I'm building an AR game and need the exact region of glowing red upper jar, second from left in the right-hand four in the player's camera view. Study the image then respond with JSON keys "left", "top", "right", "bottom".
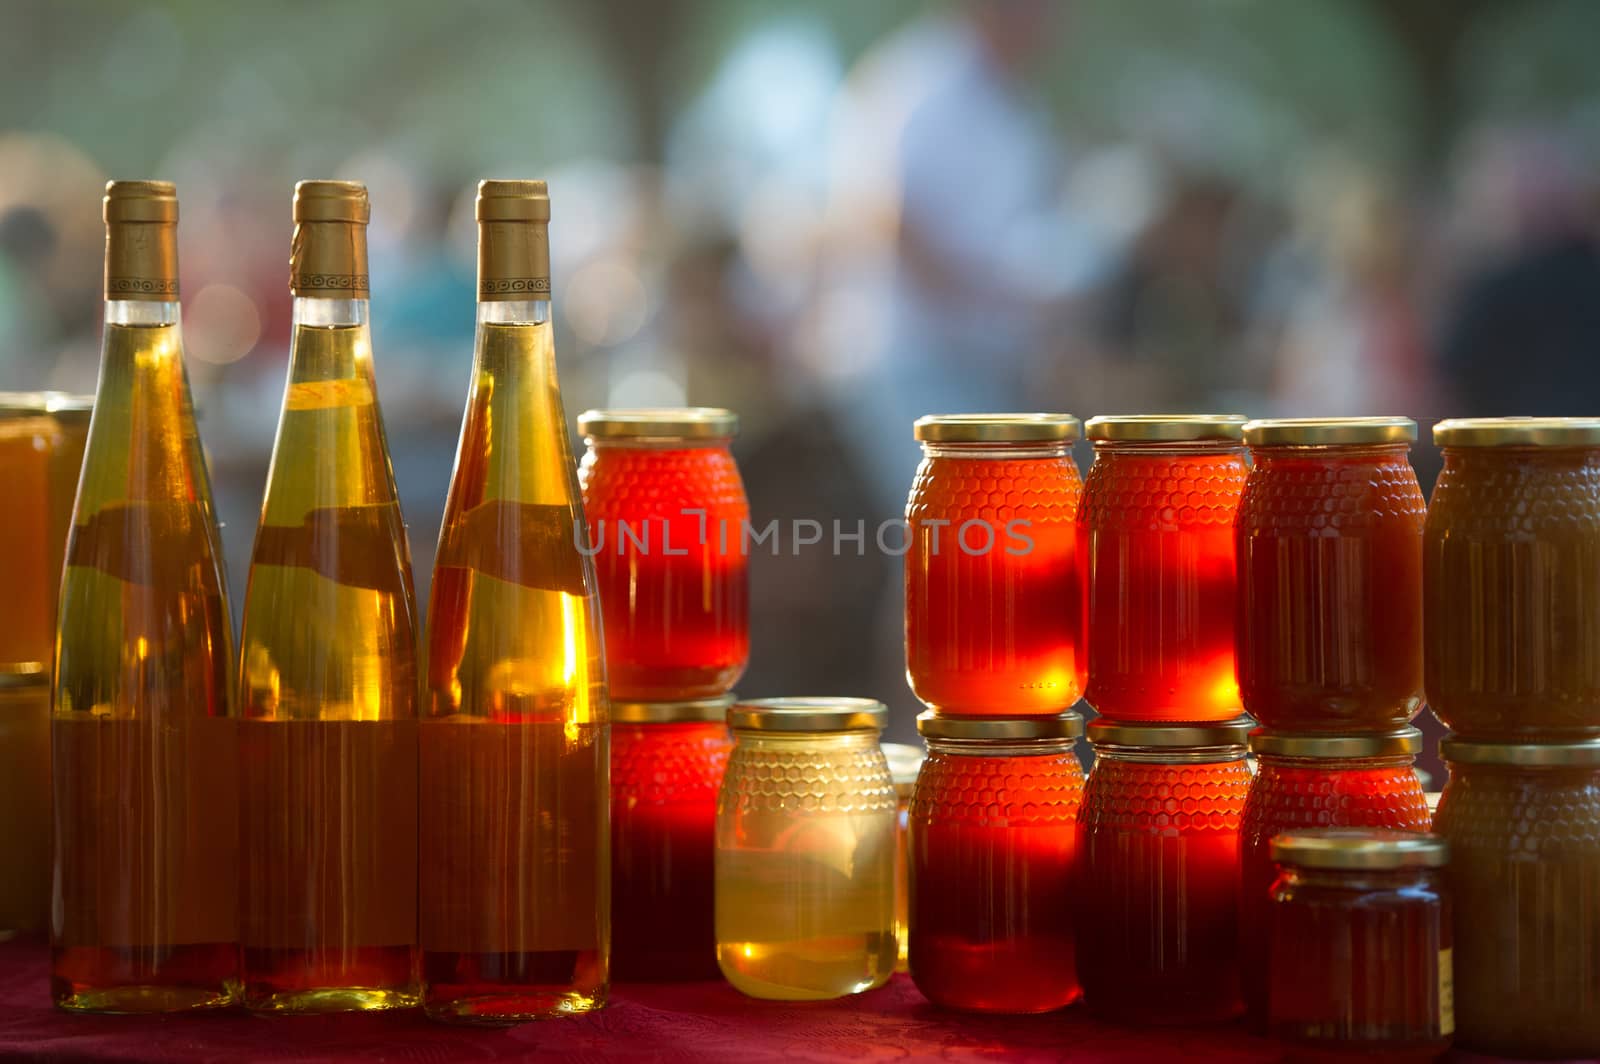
{"left": 1078, "top": 414, "right": 1246, "bottom": 722}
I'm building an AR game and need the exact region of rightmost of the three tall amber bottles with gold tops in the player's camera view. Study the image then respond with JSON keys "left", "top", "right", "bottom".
{"left": 419, "top": 181, "right": 611, "bottom": 1022}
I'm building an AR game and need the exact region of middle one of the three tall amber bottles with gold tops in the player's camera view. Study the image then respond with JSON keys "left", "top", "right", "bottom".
{"left": 240, "top": 181, "right": 419, "bottom": 1013}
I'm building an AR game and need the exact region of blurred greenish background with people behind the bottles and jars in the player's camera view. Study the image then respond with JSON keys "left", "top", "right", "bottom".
{"left": 0, "top": 0, "right": 1600, "bottom": 736}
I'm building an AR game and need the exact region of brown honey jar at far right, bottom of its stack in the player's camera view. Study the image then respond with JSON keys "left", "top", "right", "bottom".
{"left": 1434, "top": 739, "right": 1600, "bottom": 1058}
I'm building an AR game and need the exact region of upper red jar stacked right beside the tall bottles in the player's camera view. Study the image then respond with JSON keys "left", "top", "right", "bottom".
{"left": 578, "top": 406, "right": 750, "bottom": 702}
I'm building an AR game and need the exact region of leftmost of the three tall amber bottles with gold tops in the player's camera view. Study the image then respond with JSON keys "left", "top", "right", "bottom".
{"left": 50, "top": 181, "right": 238, "bottom": 1013}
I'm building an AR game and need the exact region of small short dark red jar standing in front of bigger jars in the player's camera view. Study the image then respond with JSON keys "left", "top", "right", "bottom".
{"left": 1266, "top": 827, "right": 1456, "bottom": 1064}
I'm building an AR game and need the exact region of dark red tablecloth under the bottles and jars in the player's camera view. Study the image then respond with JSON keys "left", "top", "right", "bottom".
{"left": 0, "top": 942, "right": 1523, "bottom": 1064}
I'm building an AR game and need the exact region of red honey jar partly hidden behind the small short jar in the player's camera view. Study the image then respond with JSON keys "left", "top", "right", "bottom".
{"left": 1238, "top": 728, "right": 1429, "bottom": 1026}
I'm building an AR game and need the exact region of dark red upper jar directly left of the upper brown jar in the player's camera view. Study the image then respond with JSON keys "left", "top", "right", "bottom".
{"left": 1235, "top": 418, "right": 1427, "bottom": 733}
